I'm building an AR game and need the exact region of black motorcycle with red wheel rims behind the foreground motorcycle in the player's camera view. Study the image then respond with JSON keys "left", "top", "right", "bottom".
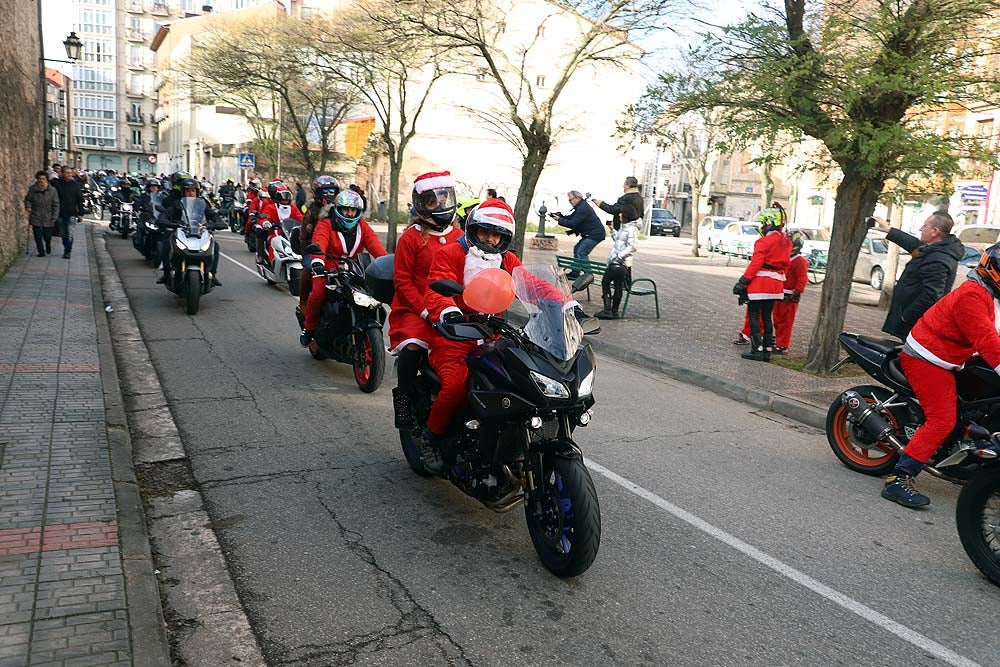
{"left": 295, "top": 244, "right": 387, "bottom": 394}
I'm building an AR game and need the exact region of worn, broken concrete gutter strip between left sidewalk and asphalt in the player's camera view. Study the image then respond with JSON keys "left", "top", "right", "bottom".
{"left": 90, "top": 224, "right": 266, "bottom": 667}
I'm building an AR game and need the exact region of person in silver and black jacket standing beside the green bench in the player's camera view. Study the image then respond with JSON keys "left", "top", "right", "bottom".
{"left": 587, "top": 176, "right": 642, "bottom": 320}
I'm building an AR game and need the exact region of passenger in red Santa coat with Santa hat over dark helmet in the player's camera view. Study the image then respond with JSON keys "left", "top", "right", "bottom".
{"left": 389, "top": 171, "right": 462, "bottom": 428}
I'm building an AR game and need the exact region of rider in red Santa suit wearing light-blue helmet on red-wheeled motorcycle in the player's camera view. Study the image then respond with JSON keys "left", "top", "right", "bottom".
{"left": 299, "top": 190, "right": 386, "bottom": 347}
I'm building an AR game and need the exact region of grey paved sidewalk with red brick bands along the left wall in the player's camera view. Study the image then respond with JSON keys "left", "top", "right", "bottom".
{"left": 0, "top": 223, "right": 170, "bottom": 667}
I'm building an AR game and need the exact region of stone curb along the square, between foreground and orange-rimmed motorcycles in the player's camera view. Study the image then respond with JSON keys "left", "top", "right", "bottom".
{"left": 589, "top": 336, "right": 826, "bottom": 430}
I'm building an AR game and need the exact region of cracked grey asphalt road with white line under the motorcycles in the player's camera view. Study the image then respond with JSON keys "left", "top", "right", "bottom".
{"left": 108, "top": 232, "right": 1000, "bottom": 667}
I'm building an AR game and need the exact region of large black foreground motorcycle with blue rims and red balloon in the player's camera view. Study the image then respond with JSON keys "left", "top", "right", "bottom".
{"left": 370, "top": 258, "right": 601, "bottom": 577}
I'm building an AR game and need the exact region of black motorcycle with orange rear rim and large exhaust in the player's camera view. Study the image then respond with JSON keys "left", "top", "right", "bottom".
{"left": 826, "top": 332, "right": 1000, "bottom": 484}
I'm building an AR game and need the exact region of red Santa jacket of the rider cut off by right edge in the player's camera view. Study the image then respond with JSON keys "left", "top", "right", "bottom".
{"left": 903, "top": 280, "right": 1000, "bottom": 373}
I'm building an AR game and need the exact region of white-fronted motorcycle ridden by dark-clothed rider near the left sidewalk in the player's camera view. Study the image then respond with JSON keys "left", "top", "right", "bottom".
{"left": 162, "top": 197, "right": 224, "bottom": 315}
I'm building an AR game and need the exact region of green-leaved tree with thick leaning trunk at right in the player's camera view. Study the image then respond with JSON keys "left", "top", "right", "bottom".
{"left": 658, "top": 0, "right": 1000, "bottom": 372}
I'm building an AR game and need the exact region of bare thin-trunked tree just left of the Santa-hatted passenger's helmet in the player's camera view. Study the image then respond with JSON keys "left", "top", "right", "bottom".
{"left": 310, "top": 0, "right": 443, "bottom": 251}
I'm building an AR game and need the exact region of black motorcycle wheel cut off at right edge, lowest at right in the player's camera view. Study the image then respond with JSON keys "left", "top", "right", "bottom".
{"left": 955, "top": 466, "right": 1000, "bottom": 586}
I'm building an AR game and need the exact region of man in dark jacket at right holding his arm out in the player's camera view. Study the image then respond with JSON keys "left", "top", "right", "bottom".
{"left": 875, "top": 211, "right": 965, "bottom": 340}
